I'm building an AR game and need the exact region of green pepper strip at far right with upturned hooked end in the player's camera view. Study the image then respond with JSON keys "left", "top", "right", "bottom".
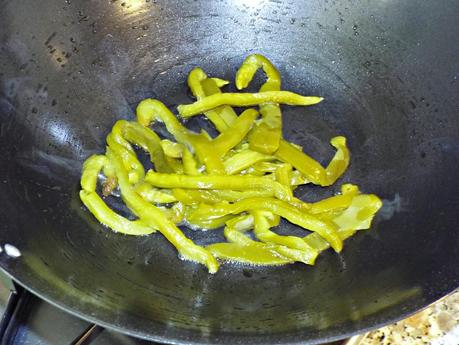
{"left": 275, "top": 137, "right": 349, "bottom": 186}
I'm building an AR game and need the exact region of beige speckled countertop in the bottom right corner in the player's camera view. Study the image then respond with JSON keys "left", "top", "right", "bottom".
{"left": 346, "top": 289, "right": 459, "bottom": 345}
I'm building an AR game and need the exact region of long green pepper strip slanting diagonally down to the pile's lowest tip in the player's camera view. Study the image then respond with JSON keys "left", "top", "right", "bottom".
{"left": 107, "top": 147, "right": 218, "bottom": 273}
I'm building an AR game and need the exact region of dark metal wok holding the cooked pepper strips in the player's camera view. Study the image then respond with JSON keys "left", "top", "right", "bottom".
{"left": 0, "top": 0, "right": 459, "bottom": 344}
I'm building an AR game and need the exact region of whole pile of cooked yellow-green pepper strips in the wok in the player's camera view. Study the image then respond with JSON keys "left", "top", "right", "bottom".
{"left": 80, "top": 54, "right": 382, "bottom": 273}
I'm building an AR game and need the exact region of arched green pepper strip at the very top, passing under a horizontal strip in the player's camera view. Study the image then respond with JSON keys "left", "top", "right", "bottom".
{"left": 236, "top": 54, "right": 282, "bottom": 154}
